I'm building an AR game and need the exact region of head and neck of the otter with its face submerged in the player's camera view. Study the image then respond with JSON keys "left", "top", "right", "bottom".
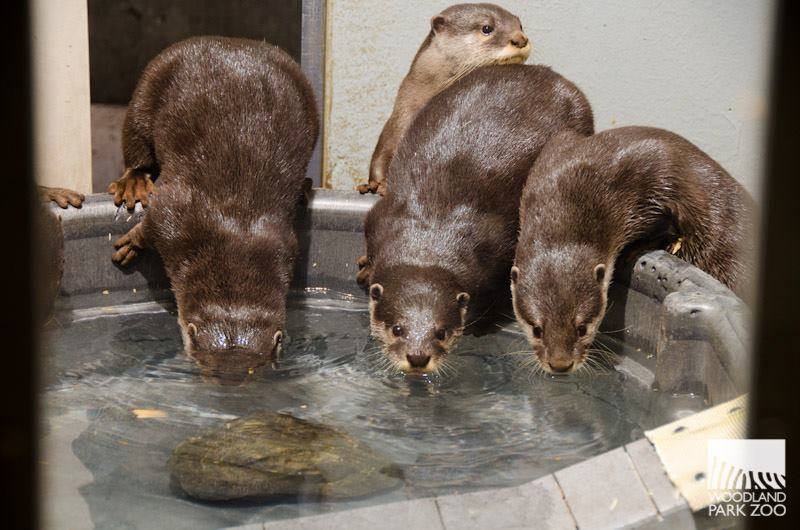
{"left": 165, "top": 229, "right": 293, "bottom": 382}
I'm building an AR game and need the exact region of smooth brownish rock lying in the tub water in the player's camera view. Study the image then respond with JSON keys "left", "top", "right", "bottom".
{"left": 169, "top": 412, "right": 402, "bottom": 501}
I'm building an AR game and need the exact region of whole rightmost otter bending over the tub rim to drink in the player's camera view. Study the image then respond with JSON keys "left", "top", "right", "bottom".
{"left": 511, "top": 127, "right": 754, "bottom": 372}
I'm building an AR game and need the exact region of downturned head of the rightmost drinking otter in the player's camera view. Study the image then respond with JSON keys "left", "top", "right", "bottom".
{"left": 511, "top": 246, "right": 611, "bottom": 373}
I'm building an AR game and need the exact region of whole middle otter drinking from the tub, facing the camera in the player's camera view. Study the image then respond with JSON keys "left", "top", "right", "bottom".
{"left": 358, "top": 65, "right": 593, "bottom": 372}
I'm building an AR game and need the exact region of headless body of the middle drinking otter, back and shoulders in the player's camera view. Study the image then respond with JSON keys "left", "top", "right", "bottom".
{"left": 366, "top": 65, "right": 593, "bottom": 330}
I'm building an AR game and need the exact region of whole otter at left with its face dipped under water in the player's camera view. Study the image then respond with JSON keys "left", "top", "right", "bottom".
{"left": 108, "top": 37, "right": 318, "bottom": 378}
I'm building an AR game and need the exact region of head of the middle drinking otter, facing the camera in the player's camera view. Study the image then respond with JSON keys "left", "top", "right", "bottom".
{"left": 369, "top": 268, "right": 469, "bottom": 373}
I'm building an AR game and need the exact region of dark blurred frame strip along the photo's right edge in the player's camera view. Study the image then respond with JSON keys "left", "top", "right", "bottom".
{"left": 746, "top": 0, "right": 800, "bottom": 528}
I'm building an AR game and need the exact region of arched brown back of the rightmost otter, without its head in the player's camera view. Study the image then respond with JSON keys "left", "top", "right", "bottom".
{"left": 517, "top": 127, "right": 755, "bottom": 294}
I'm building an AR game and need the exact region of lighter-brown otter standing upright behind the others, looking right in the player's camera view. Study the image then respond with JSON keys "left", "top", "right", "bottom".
{"left": 358, "top": 4, "right": 531, "bottom": 195}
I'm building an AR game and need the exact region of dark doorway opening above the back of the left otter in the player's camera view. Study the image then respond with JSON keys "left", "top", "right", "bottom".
{"left": 89, "top": 0, "right": 302, "bottom": 105}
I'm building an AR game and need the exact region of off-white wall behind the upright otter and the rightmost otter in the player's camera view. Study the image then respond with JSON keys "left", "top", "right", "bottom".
{"left": 325, "top": 0, "right": 773, "bottom": 193}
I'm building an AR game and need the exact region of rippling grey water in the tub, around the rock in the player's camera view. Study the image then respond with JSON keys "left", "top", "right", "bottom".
{"left": 42, "top": 297, "right": 701, "bottom": 530}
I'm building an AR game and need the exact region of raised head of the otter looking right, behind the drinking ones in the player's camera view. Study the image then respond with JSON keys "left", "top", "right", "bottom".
{"left": 431, "top": 4, "right": 531, "bottom": 69}
